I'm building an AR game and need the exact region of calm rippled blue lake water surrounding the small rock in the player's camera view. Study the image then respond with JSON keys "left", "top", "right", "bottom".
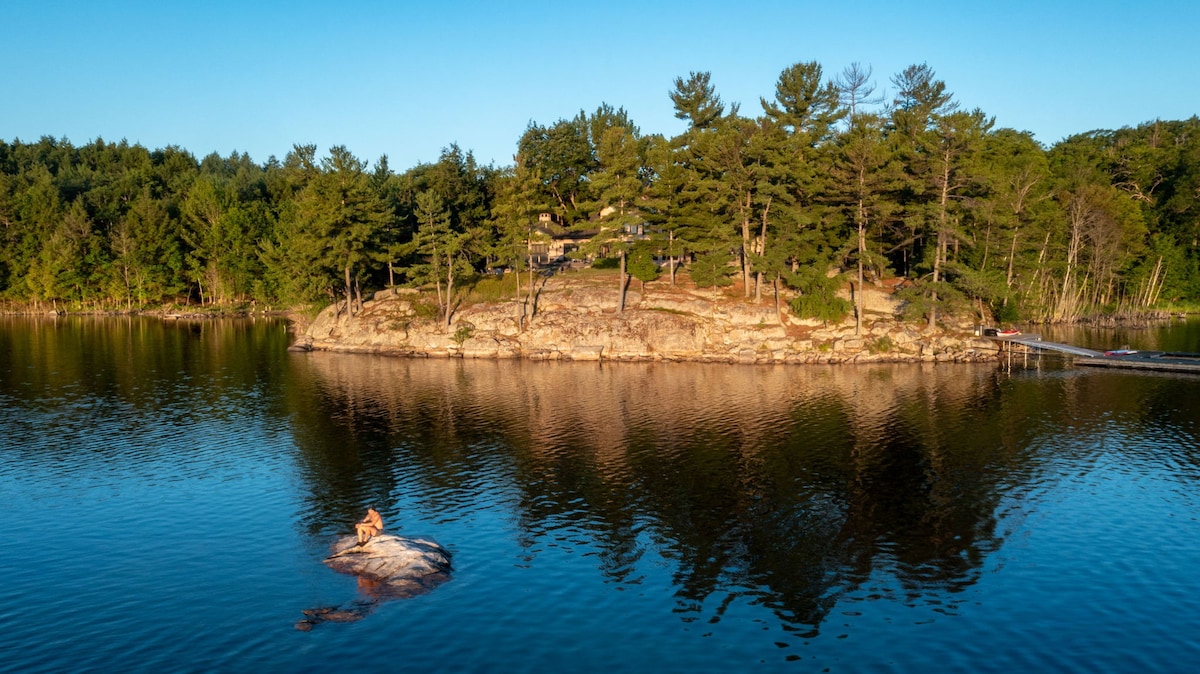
{"left": 0, "top": 318, "right": 1200, "bottom": 673}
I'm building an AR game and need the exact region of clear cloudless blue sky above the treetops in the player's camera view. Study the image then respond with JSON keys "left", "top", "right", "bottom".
{"left": 0, "top": 0, "right": 1200, "bottom": 170}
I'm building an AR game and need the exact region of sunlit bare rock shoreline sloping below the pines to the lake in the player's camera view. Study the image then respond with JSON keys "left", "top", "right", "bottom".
{"left": 292, "top": 275, "right": 997, "bottom": 363}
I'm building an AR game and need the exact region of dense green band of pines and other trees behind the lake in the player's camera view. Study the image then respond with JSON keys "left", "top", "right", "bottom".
{"left": 0, "top": 62, "right": 1200, "bottom": 324}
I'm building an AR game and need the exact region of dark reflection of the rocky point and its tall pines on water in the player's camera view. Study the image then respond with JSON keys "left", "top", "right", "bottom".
{"left": 278, "top": 354, "right": 1123, "bottom": 633}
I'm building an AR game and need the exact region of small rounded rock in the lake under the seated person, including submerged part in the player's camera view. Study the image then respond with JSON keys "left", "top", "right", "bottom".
{"left": 295, "top": 534, "right": 450, "bottom": 632}
